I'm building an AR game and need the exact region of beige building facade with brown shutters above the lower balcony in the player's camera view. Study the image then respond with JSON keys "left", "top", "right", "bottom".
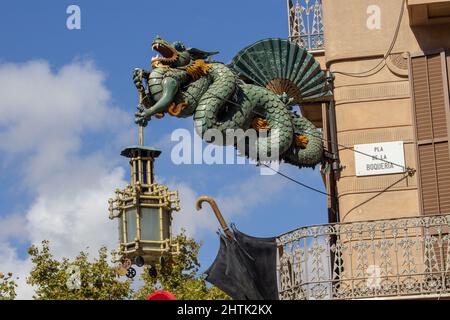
{"left": 323, "top": 0, "right": 450, "bottom": 222}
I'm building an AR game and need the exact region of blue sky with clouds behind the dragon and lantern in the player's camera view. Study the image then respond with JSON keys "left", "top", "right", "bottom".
{"left": 0, "top": 0, "right": 327, "bottom": 298}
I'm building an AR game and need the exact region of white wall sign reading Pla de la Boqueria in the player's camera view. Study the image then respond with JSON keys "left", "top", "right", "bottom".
{"left": 355, "top": 141, "right": 406, "bottom": 176}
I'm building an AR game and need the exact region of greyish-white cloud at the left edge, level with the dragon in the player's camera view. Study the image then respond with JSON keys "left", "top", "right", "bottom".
{"left": 0, "top": 61, "right": 109, "bottom": 153}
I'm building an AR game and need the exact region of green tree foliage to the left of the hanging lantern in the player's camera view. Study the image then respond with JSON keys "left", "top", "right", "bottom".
{"left": 27, "top": 241, "right": 132, "bottom": 300}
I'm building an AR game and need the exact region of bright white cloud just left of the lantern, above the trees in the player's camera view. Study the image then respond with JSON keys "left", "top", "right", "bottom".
{"left": 26, "top": 168, "right": 125, "bottom": 257}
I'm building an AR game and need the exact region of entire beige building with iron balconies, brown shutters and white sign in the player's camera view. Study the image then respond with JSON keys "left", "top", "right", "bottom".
{"left": 279, "top": 0, "right": 450, "bottom": 299}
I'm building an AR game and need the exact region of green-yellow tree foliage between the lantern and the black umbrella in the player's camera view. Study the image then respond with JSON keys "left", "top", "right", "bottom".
{"left": 134, "top": 232, "right": 230, "bottom": 300}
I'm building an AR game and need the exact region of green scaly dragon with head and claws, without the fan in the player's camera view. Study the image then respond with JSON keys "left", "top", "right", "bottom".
{"left": 134, "top": 37, "right": 323, "bottom": 167}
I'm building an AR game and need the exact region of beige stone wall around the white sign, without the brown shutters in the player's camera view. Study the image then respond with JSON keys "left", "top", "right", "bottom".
{"left": 323, "top": 0, "right": 450, "bottom": 222}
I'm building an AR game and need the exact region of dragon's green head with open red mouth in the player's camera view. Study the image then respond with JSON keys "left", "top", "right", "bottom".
{"left": 151, "top": 36, "right": 218, "bottom": 68}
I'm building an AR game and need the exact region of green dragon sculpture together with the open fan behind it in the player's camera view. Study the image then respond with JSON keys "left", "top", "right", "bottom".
{"left": 133, "top": 36, "right": 331, "bottom": 167}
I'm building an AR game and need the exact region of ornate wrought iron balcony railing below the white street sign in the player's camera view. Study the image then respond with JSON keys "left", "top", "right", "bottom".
{"left": 278, "top": 215, "right": 450, "bottom": 300}
